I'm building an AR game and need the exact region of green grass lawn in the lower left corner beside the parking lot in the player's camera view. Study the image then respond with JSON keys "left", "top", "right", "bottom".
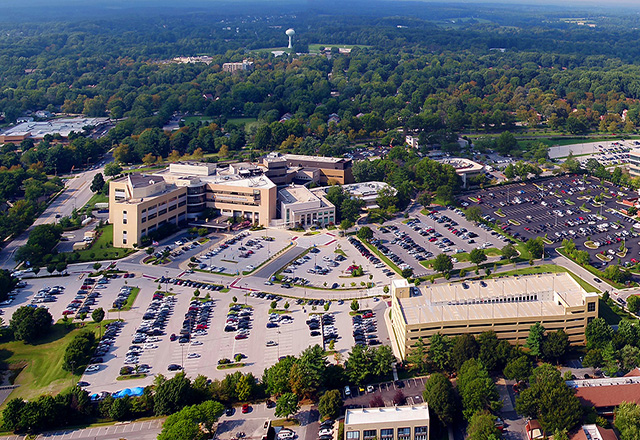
{"left": 0, "top": 321, "right": 115, "bottom": 403}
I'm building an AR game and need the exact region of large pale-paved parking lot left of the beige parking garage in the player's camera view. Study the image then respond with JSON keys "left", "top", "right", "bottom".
{"left": 75, "top": 272, "right": 389, "bottom": 393}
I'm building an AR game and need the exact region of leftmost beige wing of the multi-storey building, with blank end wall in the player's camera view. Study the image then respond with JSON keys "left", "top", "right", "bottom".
{"left": 109, "top": 174, "right": 187, "bottom": 248}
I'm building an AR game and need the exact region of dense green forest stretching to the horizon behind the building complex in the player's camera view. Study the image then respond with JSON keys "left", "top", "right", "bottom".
{"left": 5, "top": 1, "right": 640, "bottom": 241}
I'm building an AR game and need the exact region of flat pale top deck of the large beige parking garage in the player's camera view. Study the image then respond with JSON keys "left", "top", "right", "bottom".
{"left": 398, "top": 273, "right": 596, "bottom": 325}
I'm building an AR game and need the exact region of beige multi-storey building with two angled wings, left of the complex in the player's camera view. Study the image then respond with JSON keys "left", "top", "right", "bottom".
{"left": 109, "top": 163, "right": 277, "bottom": 248}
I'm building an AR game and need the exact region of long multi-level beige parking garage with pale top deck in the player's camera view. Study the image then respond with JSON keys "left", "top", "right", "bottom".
{"left": 391, "top": 273, "right": 598, "bottom": 358}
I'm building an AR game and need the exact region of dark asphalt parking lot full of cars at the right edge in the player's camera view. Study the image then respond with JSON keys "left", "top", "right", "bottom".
{"left": 460, "top": 176, "right": 640, "bottom": 268}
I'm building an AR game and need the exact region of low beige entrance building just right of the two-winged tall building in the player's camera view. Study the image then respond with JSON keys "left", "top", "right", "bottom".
{"left": 278, "top": 185, "right": 336, "bottom": 228}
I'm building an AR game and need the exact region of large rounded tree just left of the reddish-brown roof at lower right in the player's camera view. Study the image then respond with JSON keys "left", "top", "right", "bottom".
{"left": 516, "top": 364, "right": 581, "bottom": 432}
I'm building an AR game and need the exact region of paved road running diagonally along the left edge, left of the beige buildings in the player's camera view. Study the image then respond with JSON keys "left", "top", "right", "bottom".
{"left": 0, "top": 156, "right": 113, "bottom": 269}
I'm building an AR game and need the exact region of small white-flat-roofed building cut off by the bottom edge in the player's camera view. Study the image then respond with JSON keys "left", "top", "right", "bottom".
{"left": 340, "top": 403, "right": 430, "bottom": 440}
